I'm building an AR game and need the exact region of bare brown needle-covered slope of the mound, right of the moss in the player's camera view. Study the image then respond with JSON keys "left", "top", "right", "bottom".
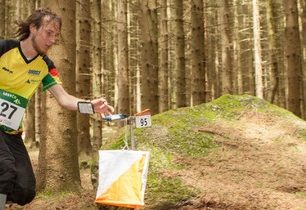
{"left": 167, "top": 113, "right": 306, "bottom": 210}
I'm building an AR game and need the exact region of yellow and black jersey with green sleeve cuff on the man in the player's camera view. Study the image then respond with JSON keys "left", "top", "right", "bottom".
{"left": 0, "top": 40, "right": 61, "bottom": 131}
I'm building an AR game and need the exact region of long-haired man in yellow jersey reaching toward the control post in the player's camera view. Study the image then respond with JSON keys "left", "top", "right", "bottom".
{"left": 0, "top": 9, "right": 113, "bottom": 210}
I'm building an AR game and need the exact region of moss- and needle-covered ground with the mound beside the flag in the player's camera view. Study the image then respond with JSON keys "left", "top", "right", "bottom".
{"left": 9, "top": 95, "right": 306, "bottom": 210}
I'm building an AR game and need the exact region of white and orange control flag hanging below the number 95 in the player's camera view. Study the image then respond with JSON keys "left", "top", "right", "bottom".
{"left": 96, "top": 150, "right": 150, "bottom": 208}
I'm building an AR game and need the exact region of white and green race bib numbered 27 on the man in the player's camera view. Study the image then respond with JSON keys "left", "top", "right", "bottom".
{"left": 0, "top": 90, "right": 28, "bottom": 130}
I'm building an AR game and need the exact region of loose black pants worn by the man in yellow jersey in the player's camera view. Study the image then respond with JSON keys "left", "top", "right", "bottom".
{"left": 0, "top": 131, "right": 36, "bottom": 205}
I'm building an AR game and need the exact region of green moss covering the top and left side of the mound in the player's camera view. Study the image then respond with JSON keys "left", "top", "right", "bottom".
{"left": 105, "top": 95, "right": 306, "bottom": 209}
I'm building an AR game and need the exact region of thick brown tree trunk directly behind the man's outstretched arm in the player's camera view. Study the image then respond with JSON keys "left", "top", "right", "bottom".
{"left": 38, "top": 1, "right": 81, "bottom": 192}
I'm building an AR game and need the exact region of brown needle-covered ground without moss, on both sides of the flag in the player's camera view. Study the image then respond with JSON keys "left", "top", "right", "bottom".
{"left": 4, "top": 95, "right": 306, "bottom": 210}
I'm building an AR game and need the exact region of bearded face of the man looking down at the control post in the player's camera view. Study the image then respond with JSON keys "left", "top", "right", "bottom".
{"left": 31, "top": 17, "right": 60, "bottom": 54}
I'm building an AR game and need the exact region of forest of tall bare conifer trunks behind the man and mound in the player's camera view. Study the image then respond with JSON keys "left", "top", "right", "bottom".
{"left": 0, "top": 0, "right": 306, "bottom": 207}
